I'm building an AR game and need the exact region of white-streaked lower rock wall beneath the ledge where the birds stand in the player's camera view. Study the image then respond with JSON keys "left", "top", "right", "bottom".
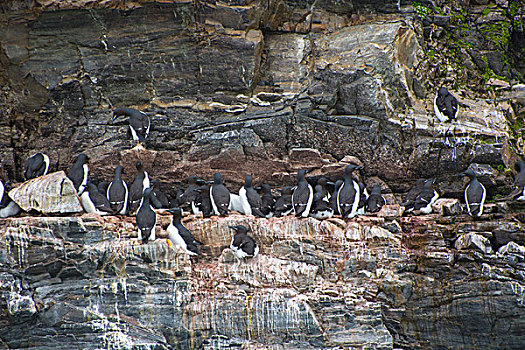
{"left": 0, "top": 211, "right": 525, "bottom": 349}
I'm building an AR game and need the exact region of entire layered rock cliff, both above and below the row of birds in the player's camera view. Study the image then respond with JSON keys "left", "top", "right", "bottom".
{"left": 0, "top": 0, "right": 525, "bottom": 350}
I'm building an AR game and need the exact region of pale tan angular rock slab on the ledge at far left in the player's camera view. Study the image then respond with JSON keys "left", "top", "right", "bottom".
{"left": 9, "top": 171, "right": 84, "bottom": 214}
